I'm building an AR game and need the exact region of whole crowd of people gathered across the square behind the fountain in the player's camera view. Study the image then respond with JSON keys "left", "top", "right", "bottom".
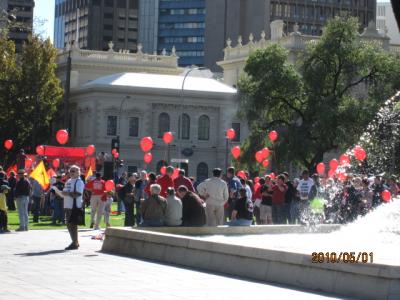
{"left": 0, "top": 166, "right": 400, "bottom": 249}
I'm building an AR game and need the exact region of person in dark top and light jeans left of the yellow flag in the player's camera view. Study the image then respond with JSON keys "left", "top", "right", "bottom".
{"left": 14, "top": 169, "right": 32, "bottom": 231}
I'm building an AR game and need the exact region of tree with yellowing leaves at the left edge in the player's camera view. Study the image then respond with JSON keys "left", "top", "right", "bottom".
{"left": 0, "top": 35, "right": 63, "bottom": 166}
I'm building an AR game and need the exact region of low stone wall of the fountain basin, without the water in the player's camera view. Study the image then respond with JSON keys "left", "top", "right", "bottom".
{"left": 102, "top": 225, "right": 400, "bottom": 299}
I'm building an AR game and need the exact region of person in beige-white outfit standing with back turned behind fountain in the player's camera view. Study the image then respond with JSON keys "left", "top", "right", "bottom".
{"left": 197, "top": 168, "right": 229, "bottom": 226}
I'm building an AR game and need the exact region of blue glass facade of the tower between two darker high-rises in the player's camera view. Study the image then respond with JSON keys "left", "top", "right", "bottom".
{"left": 157, "top": 0, "right": 206, "bottom": 66}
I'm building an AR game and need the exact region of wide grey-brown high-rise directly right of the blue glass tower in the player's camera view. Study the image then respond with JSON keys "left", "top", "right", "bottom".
{"left": 205, "top": 0, "right": 376, "bottom": 70}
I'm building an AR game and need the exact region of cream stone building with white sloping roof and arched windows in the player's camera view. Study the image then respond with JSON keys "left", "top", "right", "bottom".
{"left": 58, "top": 44, "right": 247, "bottom": 179}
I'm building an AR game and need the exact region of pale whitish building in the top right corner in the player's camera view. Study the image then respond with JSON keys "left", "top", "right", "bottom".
{"left": 376, "top": 2, "right": 400, "bottom": 44}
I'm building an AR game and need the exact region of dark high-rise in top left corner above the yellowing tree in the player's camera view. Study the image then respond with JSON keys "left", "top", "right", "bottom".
{"left": 0, "top": 0, "right": 35, "bottom": 52}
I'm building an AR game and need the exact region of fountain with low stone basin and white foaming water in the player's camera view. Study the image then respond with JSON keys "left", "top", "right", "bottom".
{"left": 102, "top": 199, "right": 400, "bottom": 299}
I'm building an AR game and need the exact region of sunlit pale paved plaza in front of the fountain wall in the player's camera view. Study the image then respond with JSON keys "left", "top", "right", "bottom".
{"left": 0, "top": 230, "right": 346, "bottom": 300}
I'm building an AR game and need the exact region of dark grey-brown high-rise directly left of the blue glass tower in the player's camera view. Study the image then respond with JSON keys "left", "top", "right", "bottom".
{"left": 54, "top": 0, "right": 139, "bottom": 51}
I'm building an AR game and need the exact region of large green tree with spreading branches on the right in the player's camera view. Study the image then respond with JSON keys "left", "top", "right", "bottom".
{"left": 239, "top": 17, "right": 400, "bottom": 170}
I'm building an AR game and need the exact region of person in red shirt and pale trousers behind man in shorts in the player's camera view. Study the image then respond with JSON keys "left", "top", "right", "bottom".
{"left": 85, "top": 173, "right": 106, "bottom": 230}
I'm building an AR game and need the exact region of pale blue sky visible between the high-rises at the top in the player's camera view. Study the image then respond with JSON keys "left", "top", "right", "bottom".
{"left": 34, "top": 0, "right": 389, "bottom": 41}
